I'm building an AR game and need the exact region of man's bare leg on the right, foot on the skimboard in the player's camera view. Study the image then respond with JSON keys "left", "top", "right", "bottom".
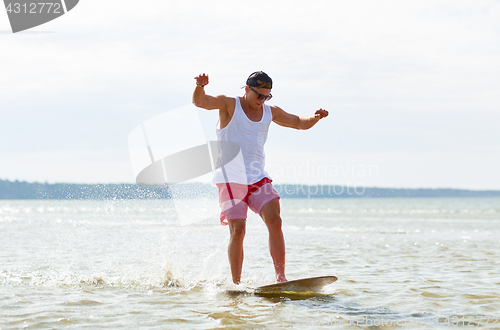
{"left": 260, "top": 198, "right": 287, "bottom": 282}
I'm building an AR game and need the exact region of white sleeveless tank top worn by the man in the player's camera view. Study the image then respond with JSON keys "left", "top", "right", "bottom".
{"left": 213, "top": 97, "right": 273, "bottom": 185}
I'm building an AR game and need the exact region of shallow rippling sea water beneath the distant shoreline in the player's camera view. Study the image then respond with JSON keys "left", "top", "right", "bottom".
{"left": 0, "top": 198, "right": 500, "bottom": 330}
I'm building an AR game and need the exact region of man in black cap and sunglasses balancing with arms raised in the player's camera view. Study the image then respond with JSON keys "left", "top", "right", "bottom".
{"left": 193, "top": 71, "right": 328, "bottom": 284}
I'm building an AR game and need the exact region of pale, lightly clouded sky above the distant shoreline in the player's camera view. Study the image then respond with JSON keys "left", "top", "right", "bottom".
{"left": 0, "top": 0, "right": 500, "bottom": 190}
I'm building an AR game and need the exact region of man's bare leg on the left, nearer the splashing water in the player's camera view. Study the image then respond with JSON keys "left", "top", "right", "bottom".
{"left": 227, "top": 219, "right": 246, "bottom": 284}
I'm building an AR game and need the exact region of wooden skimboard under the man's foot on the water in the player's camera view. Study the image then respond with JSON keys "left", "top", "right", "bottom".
{"left": 254, "top": 276, "right": 337, "bottom": 297}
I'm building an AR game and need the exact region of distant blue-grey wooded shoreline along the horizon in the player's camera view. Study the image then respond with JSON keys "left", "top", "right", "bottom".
{"left": 0, "top": 180, "right": 500, "bottom": 200}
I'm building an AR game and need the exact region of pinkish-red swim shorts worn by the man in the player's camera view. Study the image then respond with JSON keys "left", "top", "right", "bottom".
{"left": 217, "top": 178, "right": 280, "bottom": 225}
